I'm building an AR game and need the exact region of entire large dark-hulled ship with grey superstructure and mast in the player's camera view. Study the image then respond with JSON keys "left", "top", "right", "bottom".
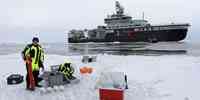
{"left": 68, "top": 1, "right": 190, "bottom": 43}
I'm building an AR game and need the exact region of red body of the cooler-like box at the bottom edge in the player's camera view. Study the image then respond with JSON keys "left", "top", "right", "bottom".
{"left": 99, "top": 88, "right": 124, "bottom": 100}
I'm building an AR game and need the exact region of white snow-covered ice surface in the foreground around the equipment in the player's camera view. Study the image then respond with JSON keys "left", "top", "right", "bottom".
{"left": 0, "top": 54, "right": 200, "bottom": 100}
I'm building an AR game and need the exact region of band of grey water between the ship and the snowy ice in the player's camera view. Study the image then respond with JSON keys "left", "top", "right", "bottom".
{"left": 0, "top": 42, "right": 200, "bottom": 56}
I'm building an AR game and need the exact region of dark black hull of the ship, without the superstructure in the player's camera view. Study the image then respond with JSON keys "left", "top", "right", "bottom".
{"left": 68, "top": 29, "right": 188, "bottom": 43}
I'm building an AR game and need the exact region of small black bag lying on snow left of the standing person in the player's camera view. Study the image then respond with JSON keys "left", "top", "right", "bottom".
{"left": 7, "top": 74, "right": 24, "bottom": 85}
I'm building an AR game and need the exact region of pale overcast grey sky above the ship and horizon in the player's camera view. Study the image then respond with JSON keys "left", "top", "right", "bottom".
{"left": 0, "top": 0, "right": 200, "bottom": 43}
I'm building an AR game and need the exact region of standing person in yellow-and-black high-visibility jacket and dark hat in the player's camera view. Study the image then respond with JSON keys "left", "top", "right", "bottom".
{"left": 22, "top": 37, "right": 44, "bottom": 90}
